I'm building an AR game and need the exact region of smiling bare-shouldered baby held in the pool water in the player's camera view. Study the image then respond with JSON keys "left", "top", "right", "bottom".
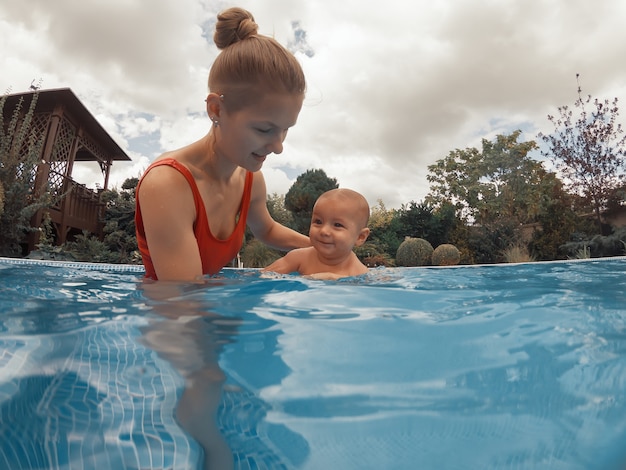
{"left": 264, "top": 189, "right": 370, "bottom": 279}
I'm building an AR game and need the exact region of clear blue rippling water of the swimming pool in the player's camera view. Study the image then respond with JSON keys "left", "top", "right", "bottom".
{"left": 0, "top": 259, "right": 626, "bottom": 470}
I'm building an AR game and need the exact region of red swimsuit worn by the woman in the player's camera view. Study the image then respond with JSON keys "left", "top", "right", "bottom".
{"left": 135, "top": 158, "right": 253, "bottom": 280}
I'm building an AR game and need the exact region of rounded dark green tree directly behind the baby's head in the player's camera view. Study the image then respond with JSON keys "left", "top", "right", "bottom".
{"left": 285, "top": 169, "right": 339, "bottom": 234}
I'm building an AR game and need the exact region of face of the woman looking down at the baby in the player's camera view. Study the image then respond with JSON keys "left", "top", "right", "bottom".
{"left": 214, "top": 93, "right": 304, "bottom": 171}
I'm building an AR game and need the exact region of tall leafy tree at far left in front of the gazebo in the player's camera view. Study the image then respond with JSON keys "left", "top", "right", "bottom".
{"left": 0, "top": 88, "right": 50, "bottom": 256}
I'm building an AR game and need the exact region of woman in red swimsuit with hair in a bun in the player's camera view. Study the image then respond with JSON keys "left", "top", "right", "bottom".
{"left": 135, "top": 8, "right": 310, "bottom": 281}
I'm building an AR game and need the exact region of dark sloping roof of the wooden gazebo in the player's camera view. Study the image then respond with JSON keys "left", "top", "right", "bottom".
{"left": 4, "top": 88, "right": 130, "bottom": 161}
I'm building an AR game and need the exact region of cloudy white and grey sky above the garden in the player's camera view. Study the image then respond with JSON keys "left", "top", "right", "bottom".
{"left": 0, "top": 0, "right": 626, "bottom": 209}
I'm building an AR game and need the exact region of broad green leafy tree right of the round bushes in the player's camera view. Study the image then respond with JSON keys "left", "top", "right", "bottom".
{"left": 425, "top": 131, "right": 573, "bottom": 263}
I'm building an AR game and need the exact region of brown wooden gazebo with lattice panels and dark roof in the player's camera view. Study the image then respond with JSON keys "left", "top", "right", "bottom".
{"left": 4, "top": 88, "right": 130, "bottom": 251}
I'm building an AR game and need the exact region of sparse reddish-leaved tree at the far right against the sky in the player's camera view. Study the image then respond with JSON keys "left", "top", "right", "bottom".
{"left": 539, "top": 74, "right": 626, "bottom": 230}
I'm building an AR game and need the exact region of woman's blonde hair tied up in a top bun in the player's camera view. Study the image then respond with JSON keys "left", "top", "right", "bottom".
{"left": 209, "top": 7, "right": 306, "bottom": 107}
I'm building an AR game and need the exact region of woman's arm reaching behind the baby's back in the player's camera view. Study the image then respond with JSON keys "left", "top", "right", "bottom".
{"left": 248, "top": 171, "right": 311, "bottom": 251}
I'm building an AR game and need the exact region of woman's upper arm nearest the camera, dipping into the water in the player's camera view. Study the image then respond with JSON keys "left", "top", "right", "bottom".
{"left": 137, "top": 166, "right": 202, "bottom": 281}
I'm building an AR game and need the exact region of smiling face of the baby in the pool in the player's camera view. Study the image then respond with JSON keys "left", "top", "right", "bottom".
{"left": 309, "top": 197, "right": 368, "bottom": 262}
